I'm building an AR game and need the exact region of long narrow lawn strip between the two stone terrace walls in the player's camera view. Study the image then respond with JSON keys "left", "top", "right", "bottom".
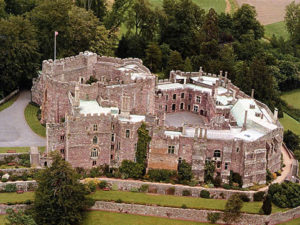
{"left": 91, "top": 191, "right": 284, "bottom": 213}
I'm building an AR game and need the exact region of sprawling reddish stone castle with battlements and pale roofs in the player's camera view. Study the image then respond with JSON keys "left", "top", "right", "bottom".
{"left": 32, "top": 52, "right": 283, "bottom": 187}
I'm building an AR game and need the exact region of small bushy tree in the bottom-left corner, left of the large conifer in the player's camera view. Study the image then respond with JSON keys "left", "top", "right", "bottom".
{"left": 5, "top": 209, "right": 37, "bottom": 225}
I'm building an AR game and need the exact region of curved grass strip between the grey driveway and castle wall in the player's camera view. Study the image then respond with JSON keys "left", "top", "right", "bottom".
{"left": 24, "top": 104, "right": 46, "bottom": 137}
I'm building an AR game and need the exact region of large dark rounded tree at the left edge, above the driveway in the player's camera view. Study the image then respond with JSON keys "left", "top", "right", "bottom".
{"left": 0, "top": 15, "right": 40, "bottom": 98}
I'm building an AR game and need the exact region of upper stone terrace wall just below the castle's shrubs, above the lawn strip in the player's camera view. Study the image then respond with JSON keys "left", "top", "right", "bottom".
{"left": 99, "top": 178, "right": 256, "bottom": 200}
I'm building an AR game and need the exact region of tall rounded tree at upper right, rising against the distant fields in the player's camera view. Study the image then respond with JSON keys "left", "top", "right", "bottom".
{"left": 233, "top": 4, "right": 264, "bottom": 40}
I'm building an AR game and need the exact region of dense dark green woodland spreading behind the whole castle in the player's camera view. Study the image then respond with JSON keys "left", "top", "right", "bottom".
{"left": 0, "top": 0, "right": 300, "bottom": 118}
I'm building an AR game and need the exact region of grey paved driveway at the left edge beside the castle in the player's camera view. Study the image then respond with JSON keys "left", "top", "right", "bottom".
{"left": 0, "top": 91, "right": 46, "bottom": 147}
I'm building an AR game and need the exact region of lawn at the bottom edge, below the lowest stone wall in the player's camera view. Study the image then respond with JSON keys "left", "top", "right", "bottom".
{"left": 82, "top": 211, "right": 216, "bottom": 225}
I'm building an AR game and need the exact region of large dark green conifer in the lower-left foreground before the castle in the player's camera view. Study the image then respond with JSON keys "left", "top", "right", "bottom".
{"left": 34, "top": 152, "right": 93, "bottom": 225}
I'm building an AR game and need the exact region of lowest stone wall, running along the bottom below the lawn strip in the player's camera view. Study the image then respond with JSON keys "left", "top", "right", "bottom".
{"left": 90, "top": 201, "right": 300, "bottom": 225}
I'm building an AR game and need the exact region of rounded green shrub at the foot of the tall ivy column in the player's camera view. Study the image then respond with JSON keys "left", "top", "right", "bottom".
{"left": 120, "top": 160, "right": 144, "bottom": 179}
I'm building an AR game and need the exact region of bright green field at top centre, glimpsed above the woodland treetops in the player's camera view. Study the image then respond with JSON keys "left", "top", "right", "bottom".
{"left": 149, "top": 0, "right": 226, "bottom": 13}
